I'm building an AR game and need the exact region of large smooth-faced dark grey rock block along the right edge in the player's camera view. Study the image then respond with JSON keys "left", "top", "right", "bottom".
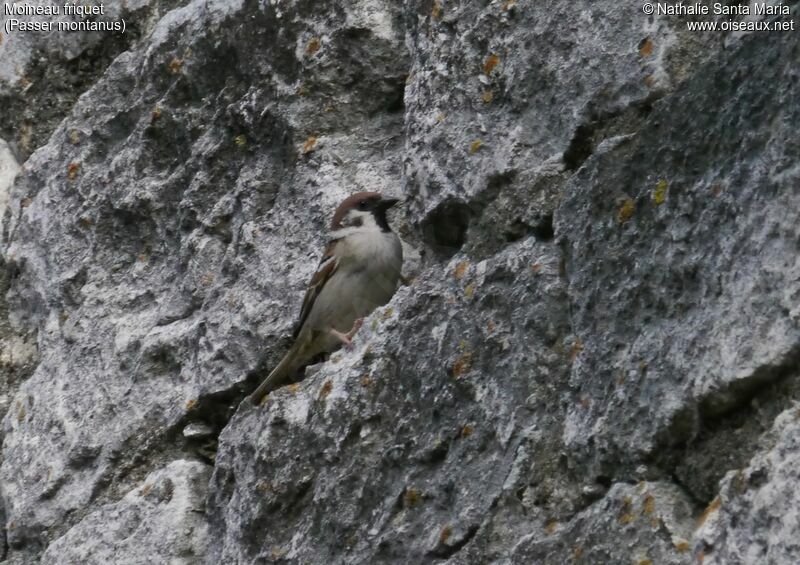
{"left": 556, "top": 25, "right": 800, "bottom": 494}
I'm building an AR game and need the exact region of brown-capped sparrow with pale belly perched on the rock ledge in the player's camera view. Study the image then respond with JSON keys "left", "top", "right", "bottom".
{"left": 250, "top": 192, "right": 403, "bottom": 405}
